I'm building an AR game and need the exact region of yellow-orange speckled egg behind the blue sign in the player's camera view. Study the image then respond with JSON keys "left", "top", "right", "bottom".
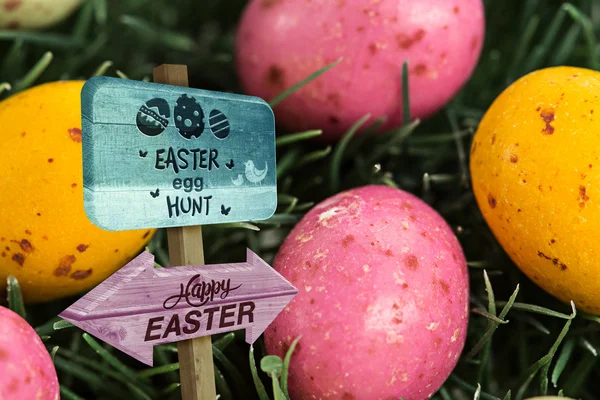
{"left": 0, "top": 81, "right": 154, "bottom": 302}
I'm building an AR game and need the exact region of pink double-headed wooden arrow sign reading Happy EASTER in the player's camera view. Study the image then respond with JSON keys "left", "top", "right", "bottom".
{"left": 59, "top": 250, "right": 298, "bottom": 366}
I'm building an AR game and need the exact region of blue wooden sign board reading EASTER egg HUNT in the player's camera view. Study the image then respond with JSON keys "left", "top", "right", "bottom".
{"left": 81, "top": 77, "right": 277, "bottom": 231}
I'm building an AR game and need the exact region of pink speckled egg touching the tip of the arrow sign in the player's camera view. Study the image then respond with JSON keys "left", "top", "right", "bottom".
{"left": 265, "top": 186, "right": 469, "bottom": 400}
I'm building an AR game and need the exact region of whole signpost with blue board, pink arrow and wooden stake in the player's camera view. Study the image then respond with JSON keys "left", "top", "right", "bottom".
{"left": 60, "top": 65, "right": 290, "bottom": 400}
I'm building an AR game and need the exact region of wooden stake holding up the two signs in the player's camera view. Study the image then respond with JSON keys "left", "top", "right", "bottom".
{"left": 153, "top": 64, "right": 217, "bottom": 400}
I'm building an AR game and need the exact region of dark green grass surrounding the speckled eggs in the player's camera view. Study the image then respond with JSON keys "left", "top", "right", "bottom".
{"left": 0, "top": 0, "right": 600, "bottom": 400}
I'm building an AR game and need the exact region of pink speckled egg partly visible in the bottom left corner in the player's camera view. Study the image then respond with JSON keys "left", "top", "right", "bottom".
{"left": 0, "top": 306, "right": 60, "bottom": 400}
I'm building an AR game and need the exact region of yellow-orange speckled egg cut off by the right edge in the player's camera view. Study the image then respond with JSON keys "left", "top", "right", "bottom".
{"left": 470, "top": 67, "right": 600, "bottom": 315}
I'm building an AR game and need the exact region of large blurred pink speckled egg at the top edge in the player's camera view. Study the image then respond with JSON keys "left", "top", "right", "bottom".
{"left": 236, "top": 0, "right": 485, "bottom": 141}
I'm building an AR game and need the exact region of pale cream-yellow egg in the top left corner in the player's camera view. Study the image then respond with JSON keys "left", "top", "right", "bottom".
{"left": 0, "top": 0, "right": 82, "bottom": 29}
